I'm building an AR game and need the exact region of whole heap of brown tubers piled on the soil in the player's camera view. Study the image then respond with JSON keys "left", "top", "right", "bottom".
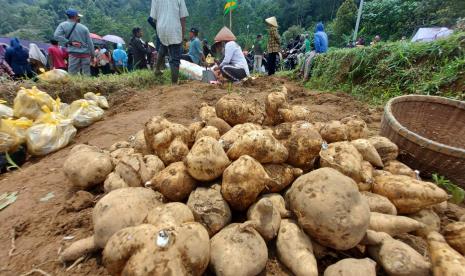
{"left": 60, "top": 88, "right": 465, "bottom": 276}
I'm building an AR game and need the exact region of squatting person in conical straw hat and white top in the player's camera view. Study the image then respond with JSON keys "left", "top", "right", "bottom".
{"left": 212, "top": 27, "right": 250, "bottom": 82}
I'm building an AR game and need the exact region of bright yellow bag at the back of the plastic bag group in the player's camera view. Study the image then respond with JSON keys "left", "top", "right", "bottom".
{"left": 13, "top": 86, "right": 54, "bottom": 120}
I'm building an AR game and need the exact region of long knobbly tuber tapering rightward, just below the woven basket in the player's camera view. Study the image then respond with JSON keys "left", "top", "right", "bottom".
{"left": 373, "top": 175, "right": 447, "bottom": 214}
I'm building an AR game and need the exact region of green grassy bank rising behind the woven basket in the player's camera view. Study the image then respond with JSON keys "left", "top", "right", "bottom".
{"left": 307, "top": 33, "right": 465, "bottom": 103}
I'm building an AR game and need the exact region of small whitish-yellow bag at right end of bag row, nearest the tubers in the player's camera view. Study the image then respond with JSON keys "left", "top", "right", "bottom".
{"left": 68, "top": 100, "right": 105, "bottom": 128}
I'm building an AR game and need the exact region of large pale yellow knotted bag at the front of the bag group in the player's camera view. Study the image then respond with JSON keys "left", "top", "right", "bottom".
{"left": 26, "top": 107, "right": 77, "bottom": 156}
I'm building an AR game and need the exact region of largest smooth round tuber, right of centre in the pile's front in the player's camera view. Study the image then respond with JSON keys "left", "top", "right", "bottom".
{"left": 287, "top": 168, "right": 370, "bottom": 250}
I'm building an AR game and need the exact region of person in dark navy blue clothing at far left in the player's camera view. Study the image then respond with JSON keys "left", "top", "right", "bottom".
{"left": 5, "top": 37, "right": 32, "bottom": 79}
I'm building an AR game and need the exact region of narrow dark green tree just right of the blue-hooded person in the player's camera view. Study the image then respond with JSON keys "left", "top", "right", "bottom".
{"left": 333, "top": 0, "right": 357, "bottom": 46}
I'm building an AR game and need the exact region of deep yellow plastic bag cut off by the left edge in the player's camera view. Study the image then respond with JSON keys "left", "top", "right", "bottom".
{"left": 0, "top": 118, "right": 32, "bottom": 152}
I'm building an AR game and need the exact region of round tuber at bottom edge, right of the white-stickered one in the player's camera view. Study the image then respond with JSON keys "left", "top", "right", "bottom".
{"left": 210, "top": 222, "right": 268, "bottom": 276}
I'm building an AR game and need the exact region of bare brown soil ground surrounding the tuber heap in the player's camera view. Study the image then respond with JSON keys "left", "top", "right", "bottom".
{"left": 0, "top": 77, "right": 382, "bottom": 276}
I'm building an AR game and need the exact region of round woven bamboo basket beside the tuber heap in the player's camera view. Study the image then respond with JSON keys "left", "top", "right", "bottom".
{"left": 381, "top": 95, "right": 465, "bottom": 188}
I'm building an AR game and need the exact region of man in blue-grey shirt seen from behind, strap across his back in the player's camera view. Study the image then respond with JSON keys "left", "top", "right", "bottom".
{"left": 54, "top": 9, "right": 94, "bottom": 76}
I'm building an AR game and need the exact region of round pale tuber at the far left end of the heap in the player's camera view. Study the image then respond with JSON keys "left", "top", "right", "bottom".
{"left": 63, "top": 145, "right": 113, "bottom": 190}
